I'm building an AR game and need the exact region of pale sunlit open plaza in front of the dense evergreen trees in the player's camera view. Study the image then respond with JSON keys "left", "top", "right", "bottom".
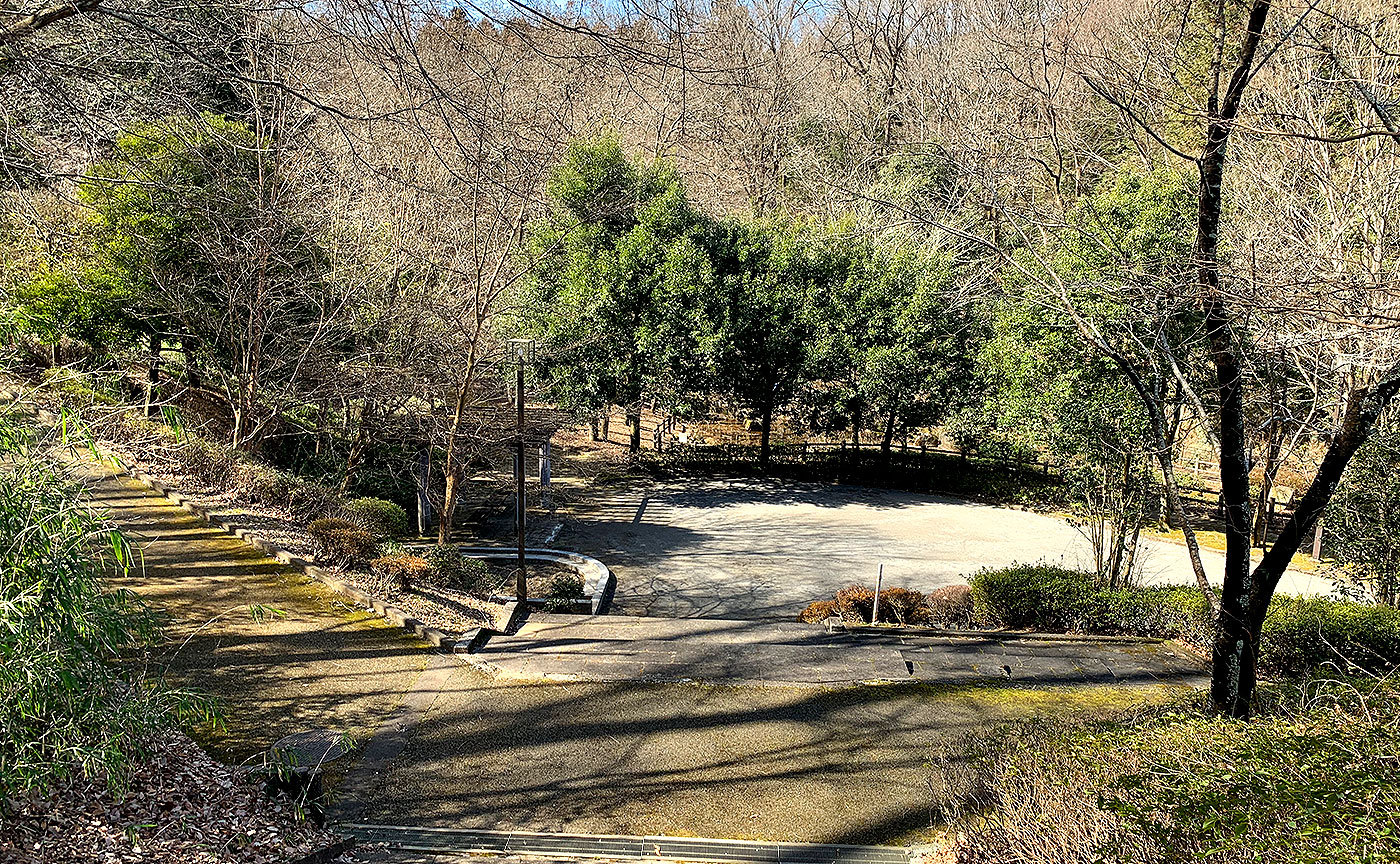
{"left": 553, "top": 480, "right": 1331, "bottom": 619}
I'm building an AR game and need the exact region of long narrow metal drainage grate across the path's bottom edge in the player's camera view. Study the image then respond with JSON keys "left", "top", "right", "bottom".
{"left": 340, "top": 823, "right": 909, "bottom": 864}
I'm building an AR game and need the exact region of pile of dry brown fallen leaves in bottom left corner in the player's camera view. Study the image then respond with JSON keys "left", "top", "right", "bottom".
{"left": 0, "top": 734, "right": 344, "bottom": 864}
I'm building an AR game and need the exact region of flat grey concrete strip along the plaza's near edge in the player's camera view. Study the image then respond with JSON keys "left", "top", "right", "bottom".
{"left": 472, "top": 613, "right": 1204, "bottom": 686}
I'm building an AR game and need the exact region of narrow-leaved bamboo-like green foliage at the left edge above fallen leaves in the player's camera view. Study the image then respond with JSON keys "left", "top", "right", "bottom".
{"left": 0, "top": 421, "right": 209, "bottom": 797}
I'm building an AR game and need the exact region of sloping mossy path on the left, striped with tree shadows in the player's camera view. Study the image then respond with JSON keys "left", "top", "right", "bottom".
{"left": 73, "top": 464, "right": 428, "bottom": 763}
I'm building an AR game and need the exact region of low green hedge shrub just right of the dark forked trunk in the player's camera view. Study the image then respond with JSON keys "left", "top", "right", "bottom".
{"left": 1259, "top": 595, "right": 1400, "bottom": 675}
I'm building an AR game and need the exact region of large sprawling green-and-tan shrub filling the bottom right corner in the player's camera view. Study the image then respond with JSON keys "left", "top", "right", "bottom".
{"left": 928, "top": 682, "right": 1400, "bottom": 864}
